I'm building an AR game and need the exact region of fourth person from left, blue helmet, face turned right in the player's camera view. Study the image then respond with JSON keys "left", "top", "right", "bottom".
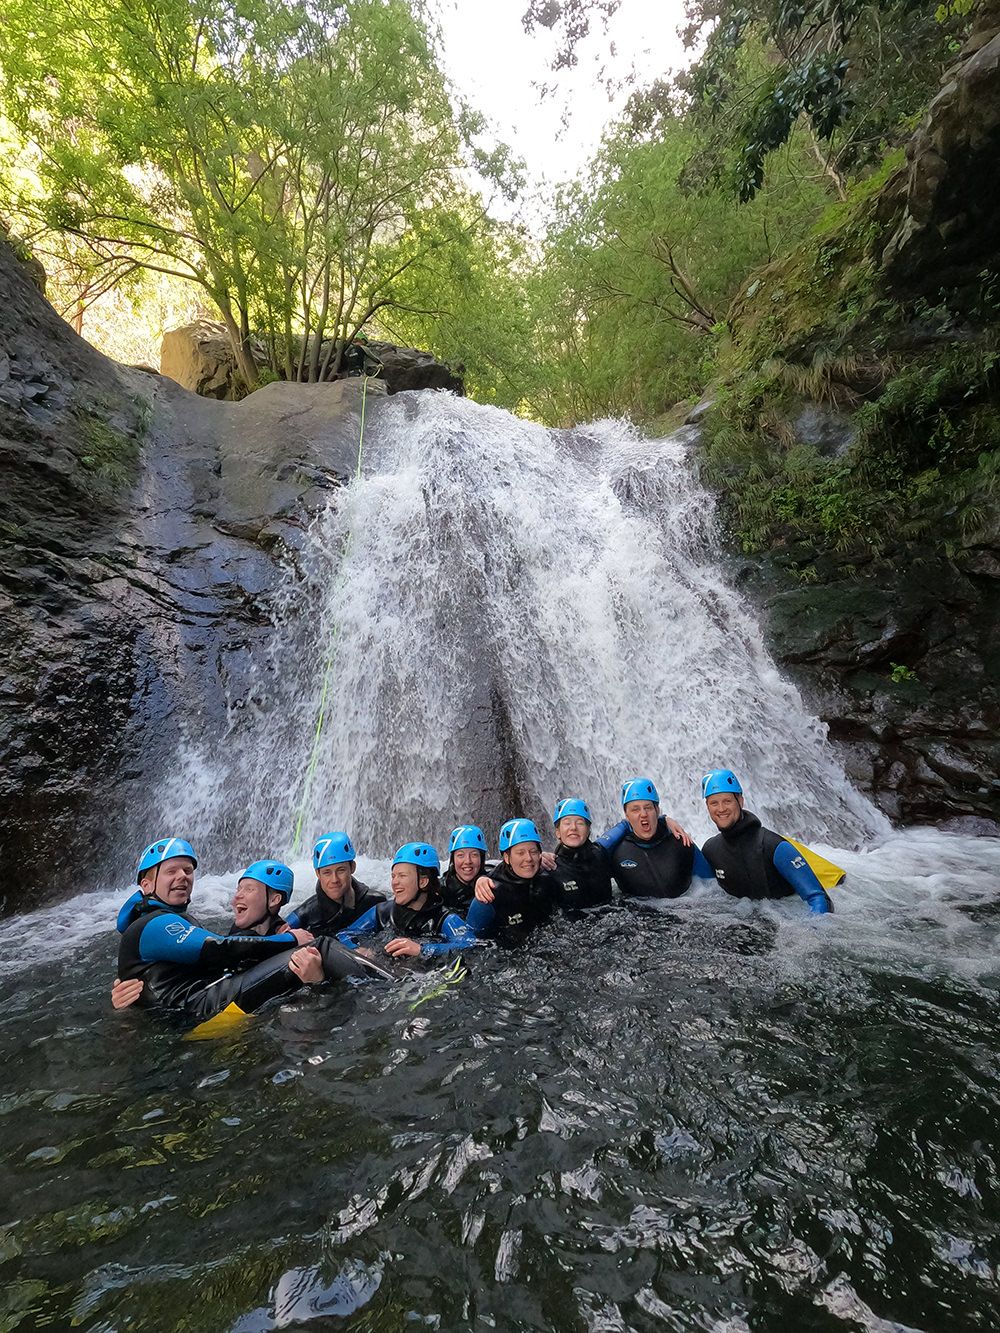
{"left": 337, "top": 842, "right": 476, "bottom": 958}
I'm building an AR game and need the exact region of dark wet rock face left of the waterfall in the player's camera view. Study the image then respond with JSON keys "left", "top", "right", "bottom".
{"left": 0, "top": 234, "right": 392, "bottom": 904}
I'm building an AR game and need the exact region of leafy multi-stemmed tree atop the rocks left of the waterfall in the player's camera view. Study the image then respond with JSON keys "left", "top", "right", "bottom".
{"left": 0, "top": 0, "right": 508, "bottom": 385}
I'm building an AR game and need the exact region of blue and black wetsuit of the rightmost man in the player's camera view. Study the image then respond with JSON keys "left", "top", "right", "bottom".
{"left": 703, "top": 810, "right": 833, "bottom": 916}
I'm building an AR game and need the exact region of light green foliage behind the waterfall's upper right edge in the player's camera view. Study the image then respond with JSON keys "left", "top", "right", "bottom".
{"left": 525, "top": 117, "right": 828, "bottom": 424}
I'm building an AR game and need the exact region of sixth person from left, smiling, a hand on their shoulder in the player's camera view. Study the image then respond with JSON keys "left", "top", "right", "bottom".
{"left": 465, "top": 820, "right": 561, "bottom": 946}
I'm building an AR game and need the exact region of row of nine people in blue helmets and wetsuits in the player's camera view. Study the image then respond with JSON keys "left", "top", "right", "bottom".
{"left": 112, "top": 769, "right": 832, "bottom": 1022}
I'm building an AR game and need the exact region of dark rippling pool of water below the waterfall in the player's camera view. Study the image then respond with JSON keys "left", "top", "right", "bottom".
{"left": 0, "top": 830, "right": 1000, "bottom": 1333}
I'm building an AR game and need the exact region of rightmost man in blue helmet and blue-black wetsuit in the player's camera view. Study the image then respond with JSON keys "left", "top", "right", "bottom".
{"left": 701, "top": 768, "right": 833, "bottom": 916}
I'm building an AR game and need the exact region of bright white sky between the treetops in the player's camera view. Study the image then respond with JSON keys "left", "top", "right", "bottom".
{"left": 437, "top": 0, "right": 691, "bottom": 221}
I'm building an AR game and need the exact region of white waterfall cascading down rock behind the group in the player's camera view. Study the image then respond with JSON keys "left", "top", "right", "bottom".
{"left": 168, "top": 393, "right": 888, "bottom": 854}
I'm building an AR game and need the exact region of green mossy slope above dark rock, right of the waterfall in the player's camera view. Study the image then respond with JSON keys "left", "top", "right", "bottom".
{"left": 703, "top": 160, "right": 1000, "bottom": 565}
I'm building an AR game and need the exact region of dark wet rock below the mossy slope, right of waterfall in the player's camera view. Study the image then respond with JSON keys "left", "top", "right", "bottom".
{"left": 747, "top": 547, "right": 1000, "bottom": 826}
